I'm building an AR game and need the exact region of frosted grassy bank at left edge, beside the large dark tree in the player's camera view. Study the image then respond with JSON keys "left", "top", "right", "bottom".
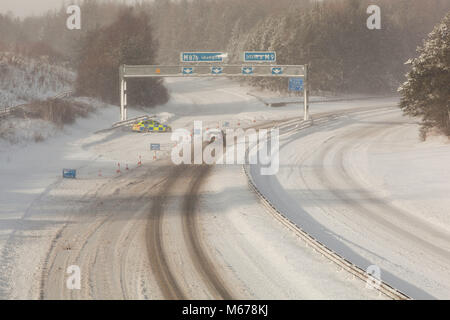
{"left": 0, "top": 52, "right": 75, "bottom": 109}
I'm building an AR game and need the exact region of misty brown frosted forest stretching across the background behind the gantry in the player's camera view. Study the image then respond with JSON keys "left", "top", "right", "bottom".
{"left": 0, "top": 0, "right": 450, "bottom": 93}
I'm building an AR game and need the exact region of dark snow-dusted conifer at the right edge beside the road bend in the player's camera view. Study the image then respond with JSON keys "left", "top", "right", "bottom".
{"left": 399, "top": 13, "right": 450, "bottom": 138}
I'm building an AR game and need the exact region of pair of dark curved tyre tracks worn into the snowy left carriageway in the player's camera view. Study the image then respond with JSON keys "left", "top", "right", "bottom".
{"left": 147, "top": 165, "right": 232, "bottom": 300}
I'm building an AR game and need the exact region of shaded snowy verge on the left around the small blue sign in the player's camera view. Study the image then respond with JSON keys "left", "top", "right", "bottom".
{"left": 0, "top": 98, "right": 168, "bottom": 299}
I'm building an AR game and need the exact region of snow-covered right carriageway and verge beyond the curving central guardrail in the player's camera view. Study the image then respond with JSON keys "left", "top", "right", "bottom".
{"left": 251, "top": 103, "right": 450, "bottom": 299}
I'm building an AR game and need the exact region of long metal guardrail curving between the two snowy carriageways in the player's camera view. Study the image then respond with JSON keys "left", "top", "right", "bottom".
{"left": 242, "top": 112, "right": 411, "bottom": 300}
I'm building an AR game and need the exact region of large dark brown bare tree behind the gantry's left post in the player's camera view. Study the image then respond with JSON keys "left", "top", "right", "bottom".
{"left": 76, "top": 8, "right": 169, "bottom": 107}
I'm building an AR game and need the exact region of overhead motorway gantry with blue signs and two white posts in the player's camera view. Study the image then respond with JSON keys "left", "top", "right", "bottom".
{"left": 120, "top": 51, "right": 309, "bottom": 121}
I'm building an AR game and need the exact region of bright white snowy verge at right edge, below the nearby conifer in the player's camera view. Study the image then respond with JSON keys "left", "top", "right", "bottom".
{"left": 364, "top": 124, "right": 450, "bottom": 234}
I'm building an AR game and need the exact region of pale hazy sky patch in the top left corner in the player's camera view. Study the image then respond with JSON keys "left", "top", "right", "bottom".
{"left": 0, "top": 0, "right": 142, "bottom": 17}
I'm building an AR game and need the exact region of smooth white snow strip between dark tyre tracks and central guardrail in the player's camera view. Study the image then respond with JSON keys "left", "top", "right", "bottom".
{"left": 200, "top": 166, "right": 382, "bottom": 300}
